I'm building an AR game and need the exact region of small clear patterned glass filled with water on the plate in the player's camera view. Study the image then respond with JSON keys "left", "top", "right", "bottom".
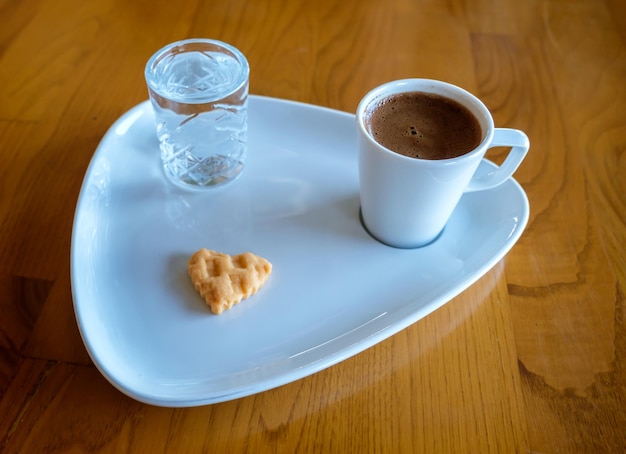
{"left": 146, "top": 39, "right": 248, "bottom": 188}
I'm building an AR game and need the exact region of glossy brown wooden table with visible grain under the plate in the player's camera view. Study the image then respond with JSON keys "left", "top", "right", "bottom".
{"left": 0, "top": 0, "right": 626, "bottom": 453}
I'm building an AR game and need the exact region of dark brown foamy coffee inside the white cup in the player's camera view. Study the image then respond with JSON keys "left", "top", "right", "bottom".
{"left": 365, "top": 92, "right": 482, "bottom": 159}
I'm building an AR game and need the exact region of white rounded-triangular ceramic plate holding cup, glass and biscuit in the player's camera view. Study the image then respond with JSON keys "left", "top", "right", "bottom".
{"left": 71, "top": 96, "right": 529, "bottom": 407}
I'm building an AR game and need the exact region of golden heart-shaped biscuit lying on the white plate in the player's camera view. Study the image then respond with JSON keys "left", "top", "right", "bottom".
{"left": 187, "top": 249, "right": 272, "bottom": 314}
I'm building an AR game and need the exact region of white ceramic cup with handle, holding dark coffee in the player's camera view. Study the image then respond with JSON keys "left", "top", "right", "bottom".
{"left": 356, "top": 79, "right": 529, "bottom": 248}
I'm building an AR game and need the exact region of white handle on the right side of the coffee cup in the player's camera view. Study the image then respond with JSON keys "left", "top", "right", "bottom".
{"left": 465, "top": 128, "right": 530, "bottom": 192}
